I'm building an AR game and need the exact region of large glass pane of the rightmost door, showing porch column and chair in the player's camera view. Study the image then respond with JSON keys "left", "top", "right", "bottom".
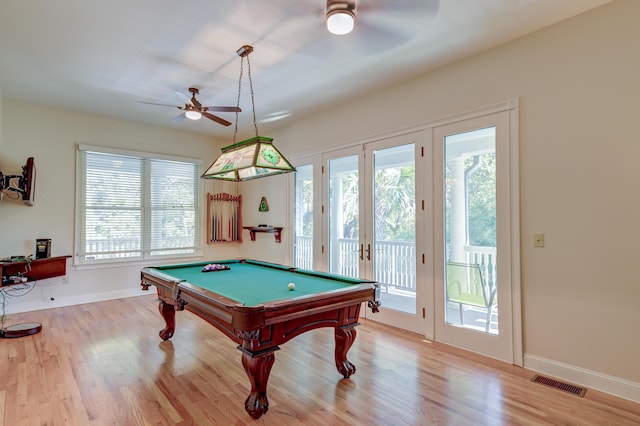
{"left": 444, "top": 127, "right": 498, "bottom": 334}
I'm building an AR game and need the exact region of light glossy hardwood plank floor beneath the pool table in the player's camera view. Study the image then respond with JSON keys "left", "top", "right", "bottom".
{"left": 0, "top": 296, "right": 640, "bottom": 426}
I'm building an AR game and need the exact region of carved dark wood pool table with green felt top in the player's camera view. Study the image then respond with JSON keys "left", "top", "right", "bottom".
{"left": 141, "top": 259, "right": 380, "bottom": 419}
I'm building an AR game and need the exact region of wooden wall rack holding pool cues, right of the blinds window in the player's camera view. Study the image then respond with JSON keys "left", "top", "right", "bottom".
{"left": 207, "top": 192, "right": 242, "bottom": 243}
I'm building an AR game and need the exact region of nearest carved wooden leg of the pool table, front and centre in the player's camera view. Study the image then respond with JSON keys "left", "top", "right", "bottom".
{"left": 242, "top": 351, "right": 275, "bottom": 419}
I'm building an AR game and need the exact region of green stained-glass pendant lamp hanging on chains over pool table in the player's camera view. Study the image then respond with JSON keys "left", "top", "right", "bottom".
{"left": 202, "top": 45, "right": 296, "bottom": 182}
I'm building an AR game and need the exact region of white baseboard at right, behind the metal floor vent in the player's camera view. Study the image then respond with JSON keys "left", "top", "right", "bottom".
{"left": 524, "top": 354, "right": 640, "bottom": 403}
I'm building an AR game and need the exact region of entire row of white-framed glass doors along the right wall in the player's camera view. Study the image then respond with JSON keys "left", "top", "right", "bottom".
{"left": 294, "top": 100, "right": 522, "bottom": 365}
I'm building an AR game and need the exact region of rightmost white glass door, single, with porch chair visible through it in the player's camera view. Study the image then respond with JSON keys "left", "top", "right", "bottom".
{"left": 433, "top": 111, "right": 517, "bottom": 362}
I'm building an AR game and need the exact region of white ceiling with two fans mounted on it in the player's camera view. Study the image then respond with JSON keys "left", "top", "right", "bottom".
{"left": 0, "top": 0, "right": 610, "bottom": 137}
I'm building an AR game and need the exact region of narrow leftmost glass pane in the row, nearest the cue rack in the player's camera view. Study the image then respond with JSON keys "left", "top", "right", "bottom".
{"left": 293, "top": 164, "right": 313, "bottom": 269}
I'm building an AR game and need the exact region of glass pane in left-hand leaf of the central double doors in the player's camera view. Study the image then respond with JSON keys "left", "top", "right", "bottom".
{"left": 328, "top": 155, "right": 360, "bottom": 277}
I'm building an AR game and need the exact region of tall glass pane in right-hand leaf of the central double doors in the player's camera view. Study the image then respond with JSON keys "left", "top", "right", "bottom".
{"left": 376, "top": 144, "right": 416, "bottom": 314}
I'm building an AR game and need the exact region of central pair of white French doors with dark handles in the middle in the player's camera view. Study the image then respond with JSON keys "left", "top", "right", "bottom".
{"left": 324, "top": 133, "right": 425, "bottom": 333}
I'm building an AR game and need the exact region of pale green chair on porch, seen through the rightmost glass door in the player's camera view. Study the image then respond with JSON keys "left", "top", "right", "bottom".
{"left": 446, "top": 262, "right": 496, "bottom": 333}
